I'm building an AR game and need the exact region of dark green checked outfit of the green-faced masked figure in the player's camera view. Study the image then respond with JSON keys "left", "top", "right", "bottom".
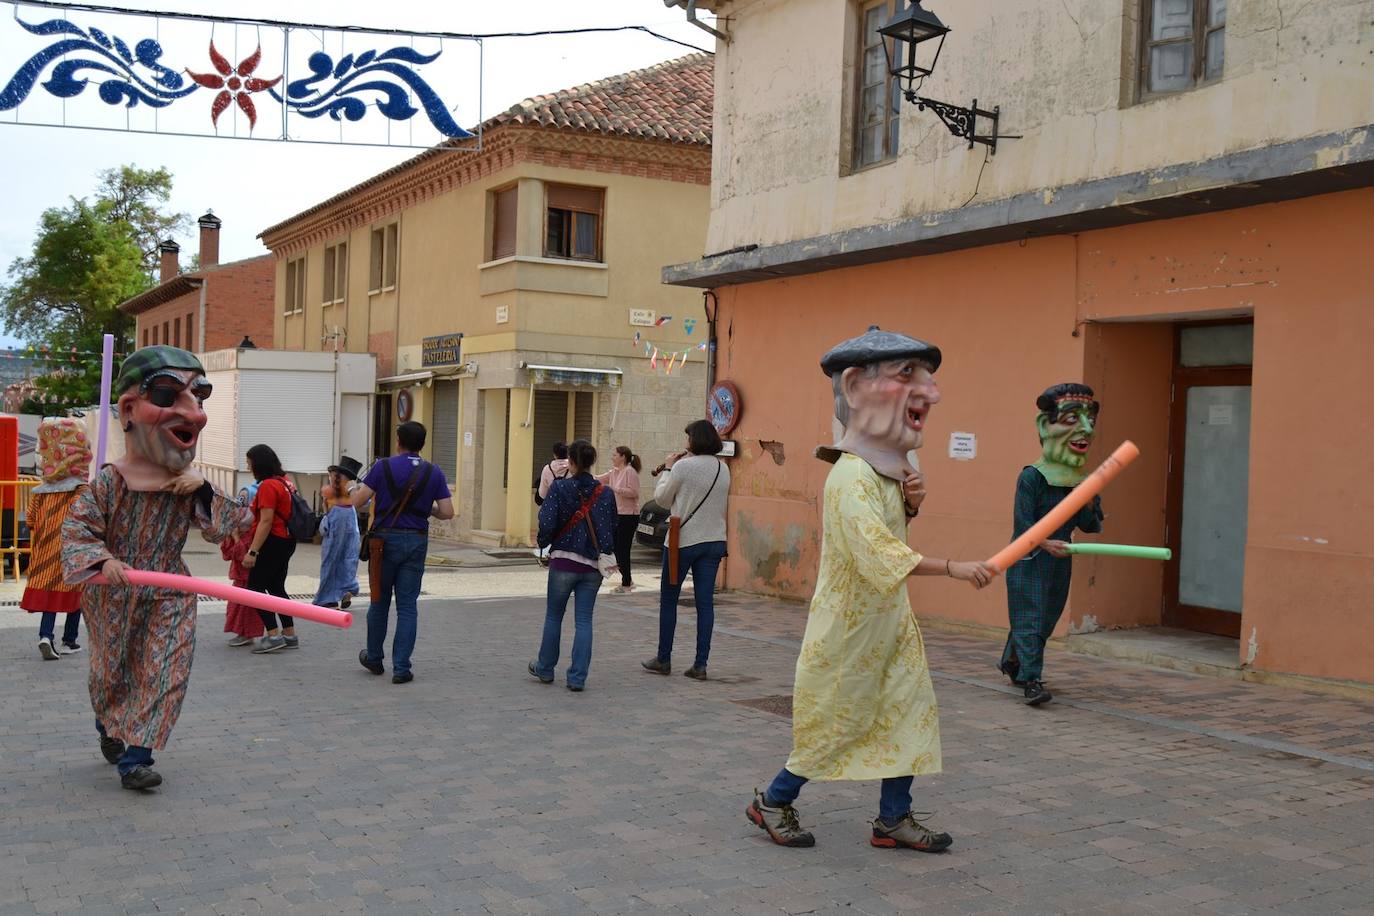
{"left": 1002, "top": 466, "right": 1102, "bottom": 681}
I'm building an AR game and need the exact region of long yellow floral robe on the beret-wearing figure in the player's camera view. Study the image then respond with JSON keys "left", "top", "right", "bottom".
{"left": 787, "top": 455, "right": 940, "bottom": 779}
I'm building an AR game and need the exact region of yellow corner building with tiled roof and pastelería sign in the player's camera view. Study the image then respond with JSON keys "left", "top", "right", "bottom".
{"left": 261, "top": 55, "right": 712, "bottom": 547}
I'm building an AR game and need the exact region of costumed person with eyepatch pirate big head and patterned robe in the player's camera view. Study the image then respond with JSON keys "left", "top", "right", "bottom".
{"left": 62, "top": 346, "right": 253, "bottom": 790}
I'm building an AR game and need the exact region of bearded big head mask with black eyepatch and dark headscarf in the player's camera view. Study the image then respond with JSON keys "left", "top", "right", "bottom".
{"left": 115, "top": 346, "right": 210, "bottom": 490}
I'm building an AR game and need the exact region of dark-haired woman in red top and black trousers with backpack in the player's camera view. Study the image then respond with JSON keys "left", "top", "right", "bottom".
{"left": 242, "top": 445, "right": 301, "bottom": 655}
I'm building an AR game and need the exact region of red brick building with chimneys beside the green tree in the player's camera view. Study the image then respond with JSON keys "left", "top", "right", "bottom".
{"left": 120, "top": 213, "right": 276, "bottom": 353}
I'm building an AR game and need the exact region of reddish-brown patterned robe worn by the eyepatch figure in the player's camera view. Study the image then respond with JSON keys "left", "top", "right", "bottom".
{"left": 62, "top": 464, "right": 253, "bottom": 750}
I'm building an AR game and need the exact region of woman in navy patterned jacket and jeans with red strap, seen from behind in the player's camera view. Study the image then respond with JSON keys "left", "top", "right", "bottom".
{"left": 529, "top": 439, "right": 616, "bottom": 691}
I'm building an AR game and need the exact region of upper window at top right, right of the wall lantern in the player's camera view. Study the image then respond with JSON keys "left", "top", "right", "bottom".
{"left": 1140, "top": 0, "right": 1226, "bottom": 96}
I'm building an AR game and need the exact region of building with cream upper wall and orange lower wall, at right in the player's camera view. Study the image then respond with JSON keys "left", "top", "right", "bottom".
{"left": 664, "top": 0, "right": 1374, "bottom": 684}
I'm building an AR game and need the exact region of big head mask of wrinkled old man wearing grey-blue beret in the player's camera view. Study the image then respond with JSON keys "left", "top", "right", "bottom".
{"left": 818, "top": 325, "right": 940, "bottom": 481}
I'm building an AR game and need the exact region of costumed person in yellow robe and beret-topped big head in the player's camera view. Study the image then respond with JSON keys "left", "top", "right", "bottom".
{"left": 746, "top": 327, "right": 995, "bottom": 853}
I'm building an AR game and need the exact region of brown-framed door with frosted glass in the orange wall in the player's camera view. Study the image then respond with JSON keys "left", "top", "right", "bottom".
{"left": 1164, "top": 321, "right": 1254, "bottom": 639}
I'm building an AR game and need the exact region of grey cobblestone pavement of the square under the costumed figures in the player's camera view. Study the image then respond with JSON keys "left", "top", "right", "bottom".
{"left": 0, "top": 587, "right": 1374, "bottom": 916}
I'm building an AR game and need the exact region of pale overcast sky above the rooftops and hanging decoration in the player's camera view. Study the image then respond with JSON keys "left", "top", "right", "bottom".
{"left": 0, "top": 0, "right": 712, "bottom": 346}
